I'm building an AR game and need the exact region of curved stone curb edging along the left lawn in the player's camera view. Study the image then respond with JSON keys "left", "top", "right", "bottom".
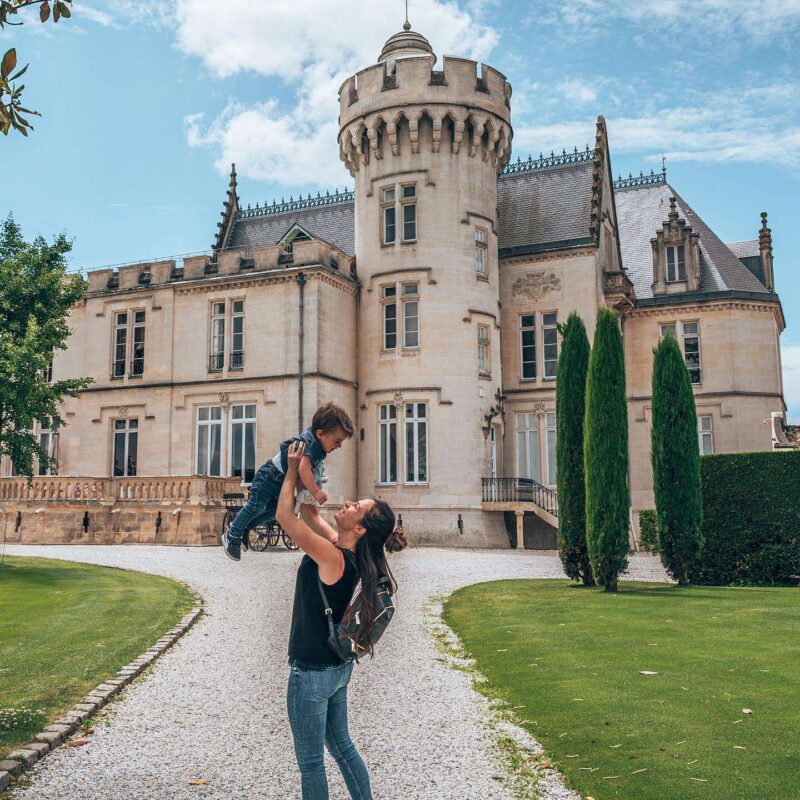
{"left": 0, "top": 581, "right": 204, "bottom": 794}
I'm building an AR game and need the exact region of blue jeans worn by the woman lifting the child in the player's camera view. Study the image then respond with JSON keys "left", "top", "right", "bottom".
{"left": 286, "top": 663, "right": 372, "bottom": 800}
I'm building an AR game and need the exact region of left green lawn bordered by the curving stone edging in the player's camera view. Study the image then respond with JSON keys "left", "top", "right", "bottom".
{"left": 0, "top": 557, "right": 193, "bottom": 757}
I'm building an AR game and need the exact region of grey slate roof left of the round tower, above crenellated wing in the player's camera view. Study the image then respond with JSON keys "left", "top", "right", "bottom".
{"left": 228, "top": 203, "right": 355, "bottom": 256}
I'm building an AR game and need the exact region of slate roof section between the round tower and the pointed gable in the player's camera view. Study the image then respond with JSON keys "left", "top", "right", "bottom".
{"left": 497, "top": 161, "right": 592, "bottom": 250}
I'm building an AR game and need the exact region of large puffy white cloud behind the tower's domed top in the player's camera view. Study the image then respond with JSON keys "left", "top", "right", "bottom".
{"left": 175, "top": 0, "right": 498, "bottom": 186}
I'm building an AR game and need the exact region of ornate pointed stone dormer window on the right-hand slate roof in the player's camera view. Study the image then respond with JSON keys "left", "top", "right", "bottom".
{"left": 650, "top": 197, "right": 700, "bottom": 295}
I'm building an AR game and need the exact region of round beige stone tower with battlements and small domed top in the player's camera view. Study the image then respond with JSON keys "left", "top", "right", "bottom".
{"left": 339, "top": 23, "right": 512, "bottom": 546}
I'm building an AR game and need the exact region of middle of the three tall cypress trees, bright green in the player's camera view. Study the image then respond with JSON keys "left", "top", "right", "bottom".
{"left": 584, "top": 308, "right": 630, "bottom": 592}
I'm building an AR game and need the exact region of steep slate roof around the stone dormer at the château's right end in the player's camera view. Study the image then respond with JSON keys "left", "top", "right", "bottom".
{"left": 615, "top": 184, "right": 767, "bottom": 299}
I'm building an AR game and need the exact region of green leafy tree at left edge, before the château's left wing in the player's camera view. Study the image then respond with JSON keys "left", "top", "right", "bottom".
{"left": 0, "top": 214, "right": 92, "bottom": 478}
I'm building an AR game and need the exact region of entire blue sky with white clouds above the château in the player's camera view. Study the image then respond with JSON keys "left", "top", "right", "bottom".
{"left": 0, "top": 0, "right": 800, "bottom": 422}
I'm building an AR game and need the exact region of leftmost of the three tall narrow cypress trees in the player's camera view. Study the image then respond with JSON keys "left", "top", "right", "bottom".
{"left": 556, "top": 312, "right": 595, "bottom": 586}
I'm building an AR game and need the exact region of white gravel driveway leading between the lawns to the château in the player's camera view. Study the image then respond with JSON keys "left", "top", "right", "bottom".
{"left": 8, "top": 545, "right": 664, "bottom": 800}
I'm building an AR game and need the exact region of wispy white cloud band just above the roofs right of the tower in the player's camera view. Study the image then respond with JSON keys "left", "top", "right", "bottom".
{"left": 514, "top": 83, "right": 800, "bottom": 170}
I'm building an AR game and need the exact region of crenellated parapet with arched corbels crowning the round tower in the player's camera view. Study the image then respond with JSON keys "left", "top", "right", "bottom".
{"left": 339, "top": 55, "right": 513, "bottom": 175}
